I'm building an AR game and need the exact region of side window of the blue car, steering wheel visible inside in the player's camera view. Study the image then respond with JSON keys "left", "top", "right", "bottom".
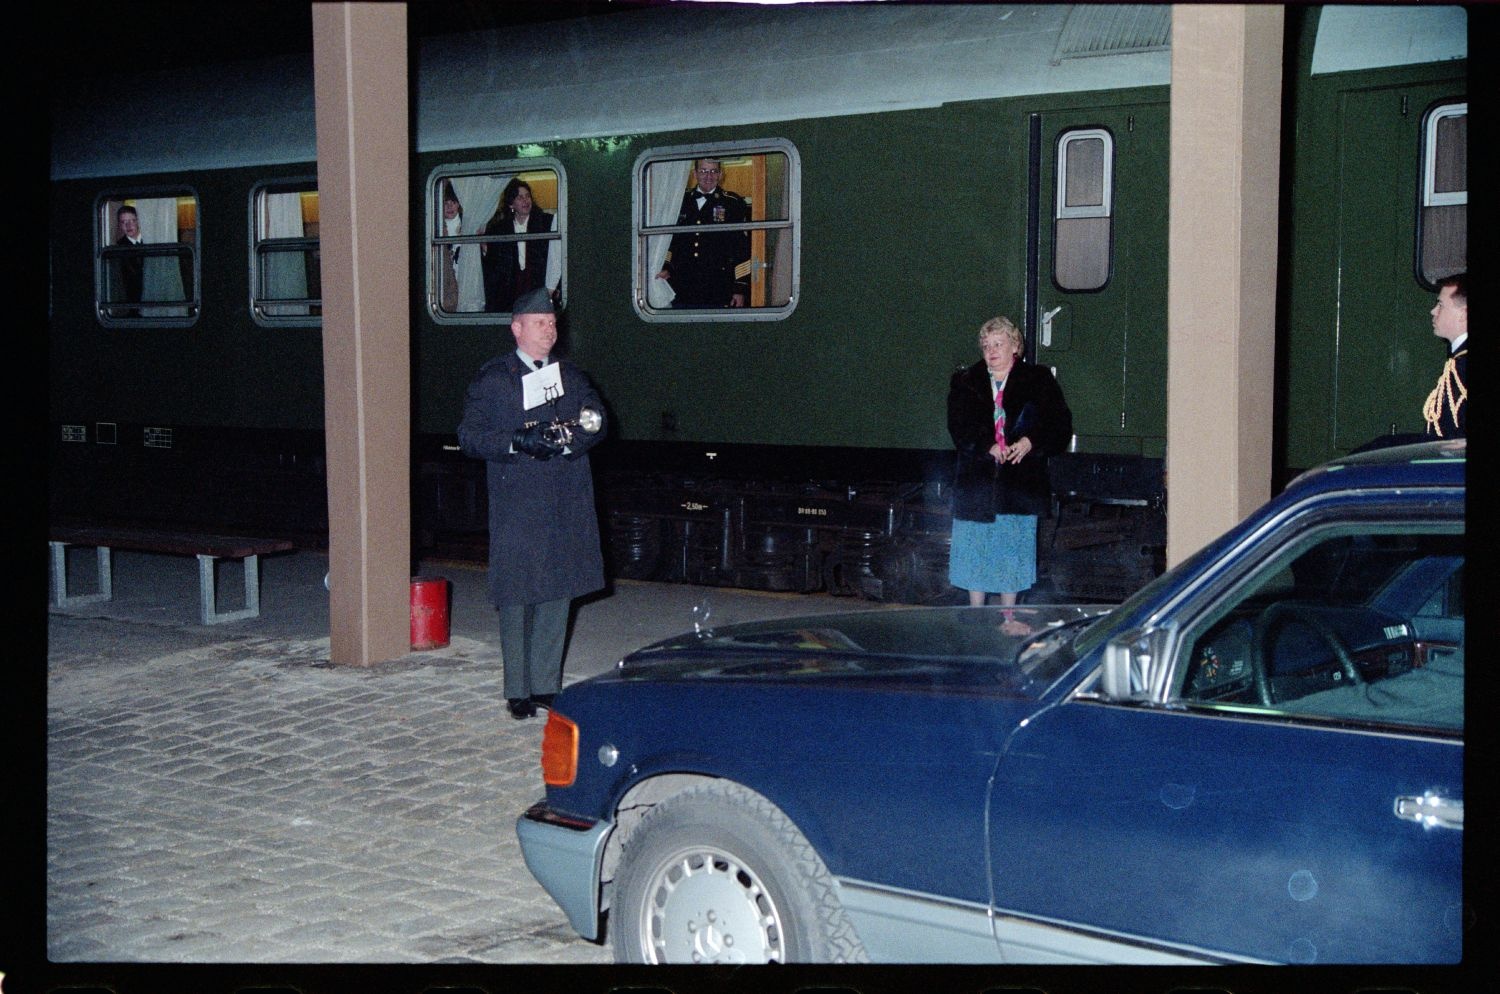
{"left": 1178, "top": 525, "right": 1464, "bottom": 730}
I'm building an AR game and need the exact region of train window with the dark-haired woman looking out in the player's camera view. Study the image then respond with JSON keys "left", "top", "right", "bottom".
{"left": 426, "top": 159, "right": 567, "bottom": 324}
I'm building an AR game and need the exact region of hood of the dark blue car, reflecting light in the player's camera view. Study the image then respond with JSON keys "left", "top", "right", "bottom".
{"left": 614, "top": 606, "right": 1107, "bottom": 696}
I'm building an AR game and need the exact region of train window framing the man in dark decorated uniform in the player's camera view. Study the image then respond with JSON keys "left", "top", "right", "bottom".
{"left": 632, "top": 139, "right": 801, "bottom": 321}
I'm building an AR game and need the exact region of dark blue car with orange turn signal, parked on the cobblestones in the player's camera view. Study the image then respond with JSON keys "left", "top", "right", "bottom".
{"left": 518, "top": 441, "right": 1466, "bottom": 963}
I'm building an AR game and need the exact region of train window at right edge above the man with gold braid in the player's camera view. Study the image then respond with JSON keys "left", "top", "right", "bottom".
{"left": 1418, "top": 102, "right": 1469, "bottom": 289}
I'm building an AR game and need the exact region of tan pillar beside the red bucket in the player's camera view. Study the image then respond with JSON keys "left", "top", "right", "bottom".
{"left": 312, "top": 3, "right": 411, "bottom": 666}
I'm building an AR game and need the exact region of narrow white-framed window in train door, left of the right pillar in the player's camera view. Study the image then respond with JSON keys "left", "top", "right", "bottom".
{"left": 1053, "top": 127, "right": 1115, "bottom": 291}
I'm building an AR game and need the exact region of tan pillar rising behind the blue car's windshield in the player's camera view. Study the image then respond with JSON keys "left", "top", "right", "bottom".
{"left": 1167, "top": 4, "right": 1283, "bottom": 565}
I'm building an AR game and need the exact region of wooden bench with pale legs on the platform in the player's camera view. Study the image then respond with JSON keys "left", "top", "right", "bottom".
{"left": 48, "top": 525, "right": 296, "bottom": 625}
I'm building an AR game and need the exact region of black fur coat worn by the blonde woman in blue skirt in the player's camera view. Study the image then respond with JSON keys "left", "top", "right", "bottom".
{"left": 948, "top": 360, "right": 1073, "bottom": 522}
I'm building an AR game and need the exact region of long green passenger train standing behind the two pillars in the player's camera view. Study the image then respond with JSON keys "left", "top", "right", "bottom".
{"left": 48, "top": 4, "right": 1467, "bottom": 601}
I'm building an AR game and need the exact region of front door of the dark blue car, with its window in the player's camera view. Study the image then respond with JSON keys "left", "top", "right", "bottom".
{"left": 989, "top": 501, "right": 1464, "bottom": 964}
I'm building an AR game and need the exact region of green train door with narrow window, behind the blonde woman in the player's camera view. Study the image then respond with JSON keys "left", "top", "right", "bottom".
{"left": 1026, "top": 103, "right": 1169, "bottom": 456}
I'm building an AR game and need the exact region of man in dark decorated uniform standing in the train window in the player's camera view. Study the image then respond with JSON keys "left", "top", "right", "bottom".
{"left": 657, "top": 159, "right": 750, "bottom": 307}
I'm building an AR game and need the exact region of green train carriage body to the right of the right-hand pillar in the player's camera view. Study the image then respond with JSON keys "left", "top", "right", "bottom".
{"left": 1278, "top": 7, "right": 1467, "bottom": 475}
